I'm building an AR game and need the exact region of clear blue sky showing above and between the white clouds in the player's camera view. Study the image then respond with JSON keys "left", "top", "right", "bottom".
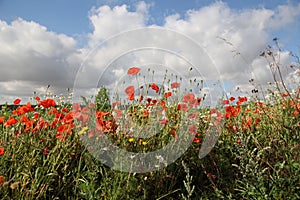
{"left": 0, "top": 0, "right": 300, "bottom": 47}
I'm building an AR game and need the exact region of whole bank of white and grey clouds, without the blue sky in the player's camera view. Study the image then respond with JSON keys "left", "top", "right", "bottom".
{"left": 0, "top": 1, "right": 300, "bottom": 104}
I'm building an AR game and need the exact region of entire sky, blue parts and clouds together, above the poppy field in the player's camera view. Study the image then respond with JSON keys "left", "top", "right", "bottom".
{"left": 0, "top": 0, "right": 300, "bottom": 104}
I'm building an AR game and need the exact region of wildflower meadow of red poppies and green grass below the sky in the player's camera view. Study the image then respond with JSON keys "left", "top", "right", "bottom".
{"left": 0, "top": 47, "right": 300, "bottom": 199}
